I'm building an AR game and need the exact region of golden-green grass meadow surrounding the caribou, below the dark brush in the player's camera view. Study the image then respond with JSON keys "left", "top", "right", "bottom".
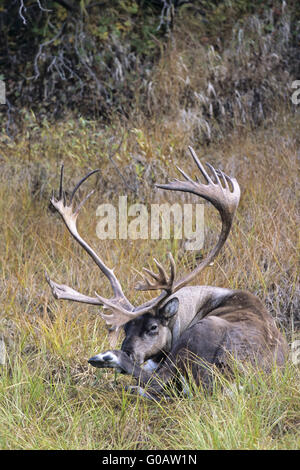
{"left": 0, "top": 108, "right": 300, "bottom": 449}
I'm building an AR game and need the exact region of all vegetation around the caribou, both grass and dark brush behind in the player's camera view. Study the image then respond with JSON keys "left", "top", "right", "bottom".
{"left": 0, "top": 0, "right": 300, "bottom": 450}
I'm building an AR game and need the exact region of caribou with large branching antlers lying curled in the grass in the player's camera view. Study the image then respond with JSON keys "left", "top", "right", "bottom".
{"left": 45, "top": 147, "right": 287, "bottom": 398}
